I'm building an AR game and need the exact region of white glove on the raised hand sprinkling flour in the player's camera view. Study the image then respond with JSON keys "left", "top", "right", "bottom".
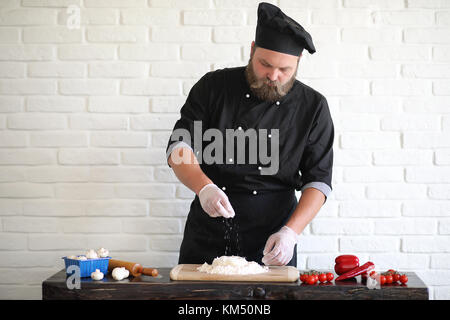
{"left": 198, "top": 183, "right": 235, "bottom": 218}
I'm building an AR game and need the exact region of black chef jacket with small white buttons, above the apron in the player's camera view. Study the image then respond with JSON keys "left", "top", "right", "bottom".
{"left": 166, "top": 67, "right": 334, "bottom": 194}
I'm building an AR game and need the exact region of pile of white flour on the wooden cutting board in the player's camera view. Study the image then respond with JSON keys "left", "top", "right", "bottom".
{"left": 197, "top": 256, "right": 269, "bottom": 275}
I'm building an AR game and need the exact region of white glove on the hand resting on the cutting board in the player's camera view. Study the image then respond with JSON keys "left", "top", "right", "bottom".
{"left": 262, "top": 226, "right": 298, "bottom": 266}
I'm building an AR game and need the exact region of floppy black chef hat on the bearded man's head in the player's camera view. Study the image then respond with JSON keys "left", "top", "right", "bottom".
{"left": 255, "top": 2, "right": 316, "bottom": 56}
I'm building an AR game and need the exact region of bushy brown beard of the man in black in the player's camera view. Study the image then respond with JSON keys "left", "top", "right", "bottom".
{"left": 245, "top": 59, "right": 297, "bottom": 102}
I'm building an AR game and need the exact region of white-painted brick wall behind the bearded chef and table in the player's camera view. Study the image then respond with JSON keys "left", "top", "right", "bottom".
{"left": 0, "top": 0, "right": 450, "bottom": 299}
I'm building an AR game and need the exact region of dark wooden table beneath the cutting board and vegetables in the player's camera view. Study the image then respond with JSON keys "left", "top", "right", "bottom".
{"left": 42, "top": 268, "right": 428, "bottom": 300}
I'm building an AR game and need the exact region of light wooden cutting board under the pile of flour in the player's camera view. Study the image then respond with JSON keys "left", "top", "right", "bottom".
{"left": 170, "top": 264, "right": 299, "bottom": 282}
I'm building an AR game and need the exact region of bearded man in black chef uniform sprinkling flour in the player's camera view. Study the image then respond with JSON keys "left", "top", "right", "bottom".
{"left": 166, "top": 3, "right": 334, "bottom": 266}
